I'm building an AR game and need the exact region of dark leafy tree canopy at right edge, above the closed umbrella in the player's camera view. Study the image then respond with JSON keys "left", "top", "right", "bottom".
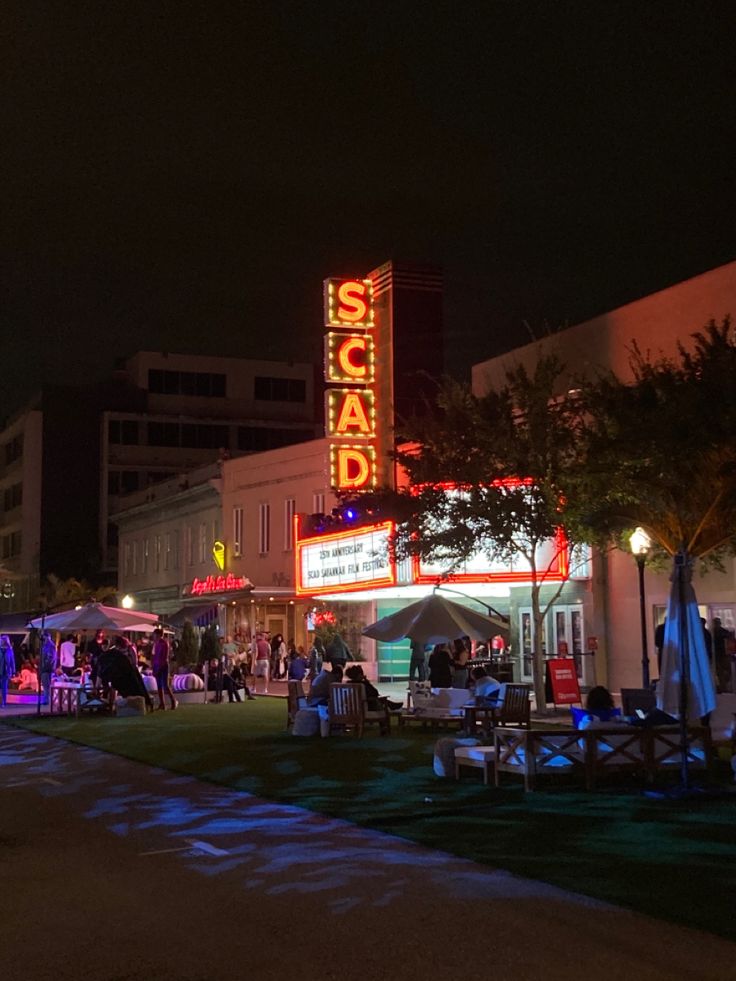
{"left": 576, "top": 318, "right": 736, "bottom": 562}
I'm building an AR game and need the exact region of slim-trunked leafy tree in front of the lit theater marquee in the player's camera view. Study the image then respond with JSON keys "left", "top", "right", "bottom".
{"left": 381, "top": 356, "right": 588, "bottom": 711}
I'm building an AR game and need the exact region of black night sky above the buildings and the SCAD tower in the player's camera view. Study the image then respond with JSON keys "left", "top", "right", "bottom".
{"left": 0, "top": 0, "right": 736, "bottom": 420}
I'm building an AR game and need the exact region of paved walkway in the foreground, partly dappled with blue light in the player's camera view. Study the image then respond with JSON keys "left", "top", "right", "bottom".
{"left": 0, "top": 726, "right": 736, "bottom": 981}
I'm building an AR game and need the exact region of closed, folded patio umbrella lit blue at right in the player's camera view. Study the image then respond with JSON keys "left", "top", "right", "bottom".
{"left": 657, "top": 552, "right": 716, "bottom": 787}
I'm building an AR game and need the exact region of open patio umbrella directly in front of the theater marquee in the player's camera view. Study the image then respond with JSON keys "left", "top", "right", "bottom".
{"left": 363, "top": 593, "right": 508, "bottom": 644}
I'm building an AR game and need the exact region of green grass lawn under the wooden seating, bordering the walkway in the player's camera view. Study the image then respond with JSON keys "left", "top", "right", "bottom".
{"left": 8, "top": 698, "right": 736, "bottom": 940}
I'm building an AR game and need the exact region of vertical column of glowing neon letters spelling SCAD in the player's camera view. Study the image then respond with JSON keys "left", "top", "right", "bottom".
{"left": 324, "top": 279, "right": 376, "bottom": 492}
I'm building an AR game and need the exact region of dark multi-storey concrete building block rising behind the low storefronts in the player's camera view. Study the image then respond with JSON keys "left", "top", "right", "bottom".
{"left": 0, "top": 352, "right": 323, "bottom": 612}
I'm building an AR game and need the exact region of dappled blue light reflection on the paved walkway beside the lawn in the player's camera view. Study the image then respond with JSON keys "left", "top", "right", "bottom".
{"left": 0, "top": 728, "right": 608, "bottom": 913}
